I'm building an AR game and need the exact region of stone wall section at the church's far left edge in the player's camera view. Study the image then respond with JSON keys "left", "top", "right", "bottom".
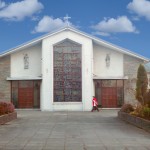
{"left": 0, "top": 56, "right": 11, "bottom": 101}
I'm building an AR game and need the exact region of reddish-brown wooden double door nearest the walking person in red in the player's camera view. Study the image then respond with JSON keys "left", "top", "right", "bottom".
{"left": 101, "top": 87, "right": 117, "bottom": 108}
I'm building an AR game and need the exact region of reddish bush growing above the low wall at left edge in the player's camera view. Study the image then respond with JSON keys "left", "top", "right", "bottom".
{"left": 0, "top": 102, "right": 14, "bottom": 115}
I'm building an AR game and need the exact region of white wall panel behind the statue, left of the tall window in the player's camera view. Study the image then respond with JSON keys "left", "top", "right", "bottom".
{"left": 11, "top": 45, "right": 41, "bottom": 78}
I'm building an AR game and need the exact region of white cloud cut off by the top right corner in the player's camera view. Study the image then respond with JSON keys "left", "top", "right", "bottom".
{"left": 127, "top": 0, "right": 150, "bottom": 20}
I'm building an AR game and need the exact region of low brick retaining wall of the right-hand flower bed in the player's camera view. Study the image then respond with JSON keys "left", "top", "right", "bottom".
{"left": 118, "top": 111, "right": 150, "bottom": 132}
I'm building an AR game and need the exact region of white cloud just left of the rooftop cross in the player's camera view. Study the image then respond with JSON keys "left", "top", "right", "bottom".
{"left": 32, "top": 16, "right": 66, "bottom": 33}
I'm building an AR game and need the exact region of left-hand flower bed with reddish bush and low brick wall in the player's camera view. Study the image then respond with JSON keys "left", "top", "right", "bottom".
{"left": 0, "top": 102, "right": 17, "bottom": 125}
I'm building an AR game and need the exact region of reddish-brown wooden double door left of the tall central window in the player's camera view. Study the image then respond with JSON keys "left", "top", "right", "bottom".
{"left": 18, "top": 88, "right": 34, "bottom": 108}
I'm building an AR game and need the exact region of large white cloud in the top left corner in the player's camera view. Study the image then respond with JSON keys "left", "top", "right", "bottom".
{"left": 0, "top": 0, "right": 44, "bottom": 21}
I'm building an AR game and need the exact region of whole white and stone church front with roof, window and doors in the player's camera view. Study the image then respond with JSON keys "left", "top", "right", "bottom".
{"left": 0, "top": 26, "right": 149, "bottom": 111}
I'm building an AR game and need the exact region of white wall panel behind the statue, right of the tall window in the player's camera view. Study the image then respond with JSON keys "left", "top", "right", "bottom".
{"left": 93, "top": 44, "right": 123, "bottom": 78}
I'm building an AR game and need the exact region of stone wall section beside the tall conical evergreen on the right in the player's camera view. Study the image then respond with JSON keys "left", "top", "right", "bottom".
{"left": 124, "top": 55, "right": 144, "bottom": 104}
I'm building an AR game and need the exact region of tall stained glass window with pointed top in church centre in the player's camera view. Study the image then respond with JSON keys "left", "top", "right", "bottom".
{"left": 54, "top": 39, "right": 82, "bottom": 102}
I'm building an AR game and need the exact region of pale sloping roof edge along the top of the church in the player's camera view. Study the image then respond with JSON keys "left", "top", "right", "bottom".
{"left": 0, "top": 26, "right": 150, "bottom": 61}
